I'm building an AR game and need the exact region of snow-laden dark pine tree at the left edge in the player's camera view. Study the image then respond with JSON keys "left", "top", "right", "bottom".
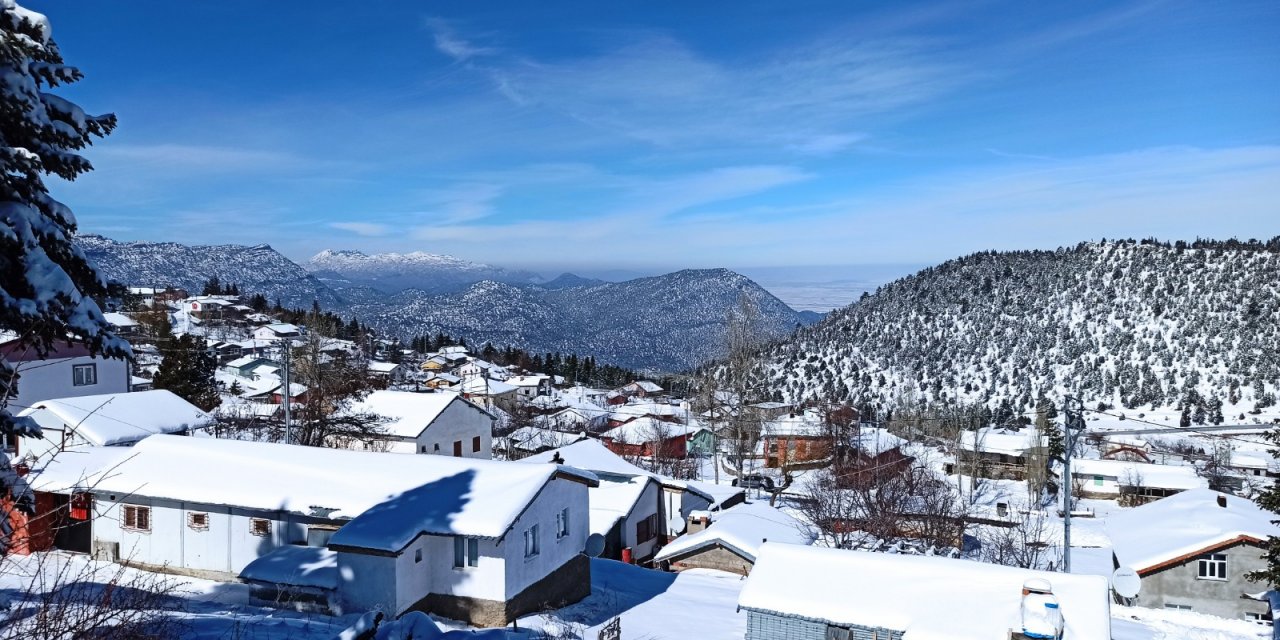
{"left": 0, "top": 0, "right": 129, "bottom": 521}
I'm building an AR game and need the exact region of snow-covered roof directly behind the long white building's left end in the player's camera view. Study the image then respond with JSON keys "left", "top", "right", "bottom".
{"left": 19, "top": 389, "right": 214, "bottom": 447}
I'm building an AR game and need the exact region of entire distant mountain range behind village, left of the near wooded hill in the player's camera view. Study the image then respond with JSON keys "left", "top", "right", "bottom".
{"left": 77, "top": 236, "right": 814, "bottom": 371}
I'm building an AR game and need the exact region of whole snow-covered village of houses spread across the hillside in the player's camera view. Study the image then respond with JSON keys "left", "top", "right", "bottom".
{"left": 0, "top": 288, "right": 1280, "bottom": 640}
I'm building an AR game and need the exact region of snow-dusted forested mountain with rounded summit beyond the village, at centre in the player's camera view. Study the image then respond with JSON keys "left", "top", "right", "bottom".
{"left": 352, "top": 269, "right": 808, "bottom": 370}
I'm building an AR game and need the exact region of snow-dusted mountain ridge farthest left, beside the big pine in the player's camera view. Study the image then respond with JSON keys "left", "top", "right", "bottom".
{"left": 76, "top": 234, "right": 346, "bottom": 308}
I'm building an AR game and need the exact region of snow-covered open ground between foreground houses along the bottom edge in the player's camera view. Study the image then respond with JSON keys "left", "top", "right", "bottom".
{"left": 0, "top": 554, "right": 1267, "bottom": 640}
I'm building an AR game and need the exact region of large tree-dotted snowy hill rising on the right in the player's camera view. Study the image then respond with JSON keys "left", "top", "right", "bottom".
{"left": 768, "top": 238, "right": 1280, "bottom": 421}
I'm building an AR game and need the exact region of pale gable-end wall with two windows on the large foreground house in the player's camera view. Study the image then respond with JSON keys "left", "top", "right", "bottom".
{"left": 504, "top": 479, "right": 593, "bottom": 599}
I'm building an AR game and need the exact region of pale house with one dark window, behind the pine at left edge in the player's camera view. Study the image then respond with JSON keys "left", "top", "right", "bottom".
{"left": 0, "top": 332, "right": 132, "bottom": 417}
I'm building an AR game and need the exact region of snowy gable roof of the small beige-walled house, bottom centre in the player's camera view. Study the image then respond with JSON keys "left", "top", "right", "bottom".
{"left": 654, "top": 502, "right": 815, "bottom": 562}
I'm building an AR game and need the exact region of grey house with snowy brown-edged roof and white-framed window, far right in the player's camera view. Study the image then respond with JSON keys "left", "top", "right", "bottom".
{"left": 1107, "top": 489, "right": 1280, "bottom": 622}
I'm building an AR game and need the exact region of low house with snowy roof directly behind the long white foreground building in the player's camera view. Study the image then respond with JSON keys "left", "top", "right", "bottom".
{"left": 15, "top": 389, "right": 214, "bottom": 458}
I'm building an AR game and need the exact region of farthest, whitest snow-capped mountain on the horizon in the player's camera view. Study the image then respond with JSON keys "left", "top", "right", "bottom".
{"left": 302, "top": 250, "right": 541, "bottom": 293}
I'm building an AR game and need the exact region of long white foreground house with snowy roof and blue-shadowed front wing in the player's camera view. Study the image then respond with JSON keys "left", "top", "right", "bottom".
{"left": 18, "top": 435, "right": 596, "bottom": 626}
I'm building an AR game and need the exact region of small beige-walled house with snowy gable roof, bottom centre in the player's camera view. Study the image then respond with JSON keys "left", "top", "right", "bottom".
{"left": 654, "top": 502, "right": 817, "bottom": 576}
